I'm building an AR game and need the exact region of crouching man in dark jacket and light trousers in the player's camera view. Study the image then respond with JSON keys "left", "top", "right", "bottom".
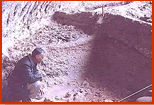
{"left": 8, "top": 48, "right": 45, "bottom": 102}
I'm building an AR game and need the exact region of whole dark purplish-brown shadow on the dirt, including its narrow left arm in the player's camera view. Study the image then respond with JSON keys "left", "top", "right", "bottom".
{"left": 53, "top": 12, "right": 152, "bottom": 101}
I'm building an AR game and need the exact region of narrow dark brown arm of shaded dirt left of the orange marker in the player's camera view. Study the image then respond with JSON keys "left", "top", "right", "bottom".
{"left": 53, "top": 12, "right": 98, "bottom": 35}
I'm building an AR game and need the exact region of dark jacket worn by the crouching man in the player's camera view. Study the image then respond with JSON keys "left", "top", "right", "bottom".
{"left": 8, "top": 55, "right": 42, "bottom": 100}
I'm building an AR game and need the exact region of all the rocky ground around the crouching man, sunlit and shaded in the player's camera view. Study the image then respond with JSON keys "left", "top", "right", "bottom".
{"left": 2, "top": 1, "right": 152, "bottom": 102}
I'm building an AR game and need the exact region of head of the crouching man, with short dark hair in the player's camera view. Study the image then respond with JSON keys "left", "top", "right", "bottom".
{"left": 32, "top": 47, "right": 45, "bottom": 63}
